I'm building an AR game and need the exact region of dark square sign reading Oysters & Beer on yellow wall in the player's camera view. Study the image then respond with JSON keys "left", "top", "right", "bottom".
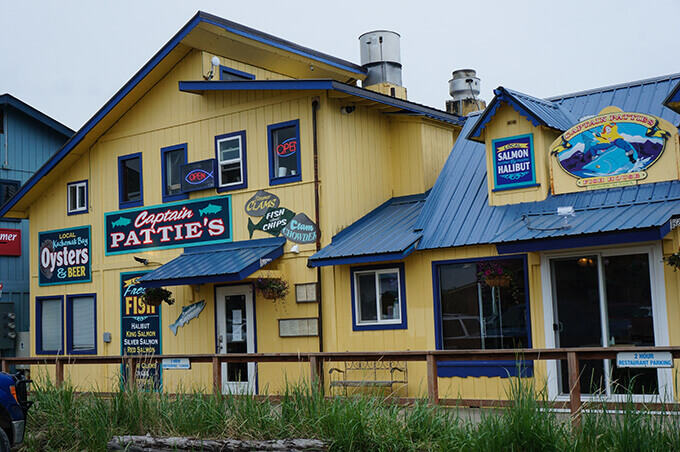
{"left": 38, "top": 226, "right": 92, "bottom": 286}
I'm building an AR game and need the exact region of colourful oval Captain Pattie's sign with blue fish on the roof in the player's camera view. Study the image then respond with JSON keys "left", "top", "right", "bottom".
{"left": 550, "top": 109, "right": 671, "bottom": 188}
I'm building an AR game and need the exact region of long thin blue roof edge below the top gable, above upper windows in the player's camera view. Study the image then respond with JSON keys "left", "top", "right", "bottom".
{"left": 179, "top": 79, "right": 463, "bottom": 126}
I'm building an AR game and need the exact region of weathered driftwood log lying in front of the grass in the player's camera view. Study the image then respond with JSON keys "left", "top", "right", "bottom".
{"left": 107, "top": 435, "right": 326, "bottom": 452}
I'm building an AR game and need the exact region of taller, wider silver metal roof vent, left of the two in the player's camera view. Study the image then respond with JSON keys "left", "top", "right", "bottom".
{"left": 359, "top": 30, "right": 402, "bottom": 87}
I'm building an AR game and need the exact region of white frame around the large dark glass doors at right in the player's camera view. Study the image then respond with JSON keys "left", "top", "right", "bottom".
{"left": 541, "top": 243, "right": 674, "bottom": 403}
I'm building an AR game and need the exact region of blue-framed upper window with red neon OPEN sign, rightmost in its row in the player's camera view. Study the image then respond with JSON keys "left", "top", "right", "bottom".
{"left": 267, "top": 120, "right": 302, "bottom": 185}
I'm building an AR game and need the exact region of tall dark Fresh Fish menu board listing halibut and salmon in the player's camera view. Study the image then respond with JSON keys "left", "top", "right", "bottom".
{"left": 120, "top": 272, "right": 162, "bottom": 389}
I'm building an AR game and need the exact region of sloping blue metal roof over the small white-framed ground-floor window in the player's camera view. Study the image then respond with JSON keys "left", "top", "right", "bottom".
{"left": 309, "top": 193, "right": 427, "bottom": 267}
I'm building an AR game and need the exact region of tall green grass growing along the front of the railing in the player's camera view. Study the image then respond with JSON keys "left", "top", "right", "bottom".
{"left": 24, "top": 379, "right": 680, "bottom": 452}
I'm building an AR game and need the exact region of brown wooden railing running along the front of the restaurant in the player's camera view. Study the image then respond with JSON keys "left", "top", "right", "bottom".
{"left": 5, "top": 346, "right": 680, "bottom": 423}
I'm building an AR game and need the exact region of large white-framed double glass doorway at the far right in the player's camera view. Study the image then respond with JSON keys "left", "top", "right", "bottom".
{"left": 541, "top": 244, "right": 673, "bottom": 402}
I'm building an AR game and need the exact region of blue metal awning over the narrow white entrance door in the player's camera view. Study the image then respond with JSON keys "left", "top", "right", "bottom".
{"left": 139, "top": 237, "right": 286, "bottom": 287}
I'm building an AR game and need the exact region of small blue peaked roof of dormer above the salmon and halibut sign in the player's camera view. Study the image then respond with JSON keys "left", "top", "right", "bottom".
{"left": 462, "top": 86, "right": 578, "bottom": 139}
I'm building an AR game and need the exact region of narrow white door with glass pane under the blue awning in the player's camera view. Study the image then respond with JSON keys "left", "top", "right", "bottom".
{"left": 215, "top": 286, "right": 255, "bottom": 394}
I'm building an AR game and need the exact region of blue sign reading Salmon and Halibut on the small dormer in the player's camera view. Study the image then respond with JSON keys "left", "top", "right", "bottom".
{"left": 492, "top": 134, "right": 536, "bottom": 190}
